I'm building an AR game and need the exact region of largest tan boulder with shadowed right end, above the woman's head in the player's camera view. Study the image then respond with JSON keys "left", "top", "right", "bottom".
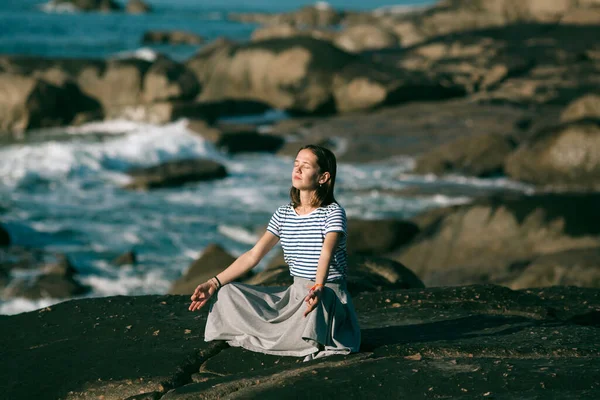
{"left": 187, "top": 37, "right": 464, "bottom": 113}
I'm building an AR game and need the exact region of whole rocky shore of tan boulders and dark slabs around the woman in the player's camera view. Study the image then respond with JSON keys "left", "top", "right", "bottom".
{"left": 0, "top": 0, "right": 600, "bottom": 400}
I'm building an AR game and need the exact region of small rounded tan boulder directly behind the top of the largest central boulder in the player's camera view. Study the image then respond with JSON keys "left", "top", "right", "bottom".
{"left": 333, "top": 25, "right": 398, "bottom": 53}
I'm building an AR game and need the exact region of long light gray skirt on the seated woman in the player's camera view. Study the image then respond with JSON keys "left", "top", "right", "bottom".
{"left": 204, "top": 277, "right": 360, "bottom": 361}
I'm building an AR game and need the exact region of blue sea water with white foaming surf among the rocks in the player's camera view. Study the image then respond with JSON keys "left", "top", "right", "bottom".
{"left": 0, "top": 0, "right": 526, "bottom": 314}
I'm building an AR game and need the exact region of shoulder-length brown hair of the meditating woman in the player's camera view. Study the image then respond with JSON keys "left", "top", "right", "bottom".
{"left": 290, "top": 144, "right": 337, "bottom": 207}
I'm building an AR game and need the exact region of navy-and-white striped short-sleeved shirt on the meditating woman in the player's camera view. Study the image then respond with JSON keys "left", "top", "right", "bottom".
{"left": 267, "top": 203, "right": 347, "bottom": 282}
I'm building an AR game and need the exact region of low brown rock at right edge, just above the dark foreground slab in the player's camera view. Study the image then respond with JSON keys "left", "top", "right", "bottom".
{"left": 508, "top": 247, "right": 600, "bottom": 289}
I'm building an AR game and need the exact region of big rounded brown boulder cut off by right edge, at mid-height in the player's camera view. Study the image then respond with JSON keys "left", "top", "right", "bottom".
{"left": 505, "top": 120, "right": 600, "bottom": 189}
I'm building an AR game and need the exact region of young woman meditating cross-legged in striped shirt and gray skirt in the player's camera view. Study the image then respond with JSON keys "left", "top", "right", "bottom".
{"left": 189, "top": 145, "right": 360, "bottom": 361}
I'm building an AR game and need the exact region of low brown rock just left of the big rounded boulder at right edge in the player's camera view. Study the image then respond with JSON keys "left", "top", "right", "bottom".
{"left": 414, "top": 134, "right": 517, "bottom": 177}
